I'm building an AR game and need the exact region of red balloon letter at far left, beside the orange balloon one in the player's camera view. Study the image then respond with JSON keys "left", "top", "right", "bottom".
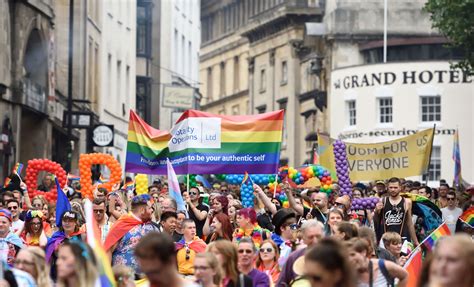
{"left": 25, "top": 159, "right": 67, "bottom": 202}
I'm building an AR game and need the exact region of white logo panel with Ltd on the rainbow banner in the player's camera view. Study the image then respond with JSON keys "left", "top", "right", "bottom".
{"left": 168, "top": 118, "right": 221, "bottom": 152}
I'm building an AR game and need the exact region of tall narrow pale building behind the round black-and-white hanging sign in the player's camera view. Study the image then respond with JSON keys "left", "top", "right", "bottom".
{"left": 97, "top": 0, "right": 137, "bottom": 167}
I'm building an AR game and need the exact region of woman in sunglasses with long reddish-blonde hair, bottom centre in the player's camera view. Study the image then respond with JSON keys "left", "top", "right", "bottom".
{"left": 256, "top": 240, "right": 281, "bottom": 286}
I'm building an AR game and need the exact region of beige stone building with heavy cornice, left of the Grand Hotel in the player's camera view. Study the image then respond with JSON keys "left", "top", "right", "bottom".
{"left": 200, "top": 0, "right": 327, "bottom": 166}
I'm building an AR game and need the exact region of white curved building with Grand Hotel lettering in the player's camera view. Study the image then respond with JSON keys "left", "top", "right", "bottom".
{"left": 325, "top": 0, "right": 474, "bottom": 185}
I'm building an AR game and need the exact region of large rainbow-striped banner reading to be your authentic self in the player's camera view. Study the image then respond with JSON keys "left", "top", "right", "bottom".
{"left": 125, "top": 110, "right": 284, "bottom": 174}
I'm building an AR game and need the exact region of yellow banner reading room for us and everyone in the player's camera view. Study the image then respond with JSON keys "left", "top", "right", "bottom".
{"left": 318, "top": 128, "right": 434, "bottom": 182}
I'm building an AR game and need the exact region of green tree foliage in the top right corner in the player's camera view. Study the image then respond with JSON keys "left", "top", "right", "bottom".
{"left": 425, "top": 0, "right": 474, "bottom": 74}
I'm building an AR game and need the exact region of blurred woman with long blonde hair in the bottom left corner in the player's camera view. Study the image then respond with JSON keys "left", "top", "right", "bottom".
{"left": 15, "top": 246, "right": 52, "bottom": 287}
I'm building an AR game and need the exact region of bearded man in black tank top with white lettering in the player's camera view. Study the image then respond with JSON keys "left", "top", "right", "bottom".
{"left": 374, "top": 177, "right": 419, "bottom": 246}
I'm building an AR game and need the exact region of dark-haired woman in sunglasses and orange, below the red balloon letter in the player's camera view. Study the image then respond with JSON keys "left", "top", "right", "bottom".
{"left": 20, "top": 210, "right": 48, "bottom": 248}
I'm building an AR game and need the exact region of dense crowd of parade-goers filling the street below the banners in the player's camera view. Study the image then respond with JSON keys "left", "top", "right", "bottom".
{"left": 0, "top": 173, "right": 474, "bottom": 287}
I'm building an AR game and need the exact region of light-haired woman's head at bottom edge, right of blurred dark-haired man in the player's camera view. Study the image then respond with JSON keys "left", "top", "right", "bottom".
{"left": 194, "top": 252, "right": 222, "bottom": 287}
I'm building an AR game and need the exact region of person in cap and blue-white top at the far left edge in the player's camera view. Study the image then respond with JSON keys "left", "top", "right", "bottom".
{"left": 0, "top": 209, "right": 24, "bottom": 267}
